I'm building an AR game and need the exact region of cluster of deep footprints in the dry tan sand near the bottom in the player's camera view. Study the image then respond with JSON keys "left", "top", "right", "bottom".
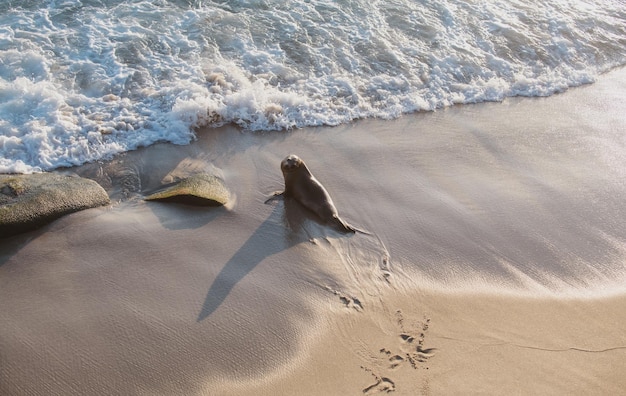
{"left": 361, "top": 310, "right": 436, "bottom": 394}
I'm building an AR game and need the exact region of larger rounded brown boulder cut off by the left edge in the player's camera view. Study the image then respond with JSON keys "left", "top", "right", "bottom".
{"left": 0, "top": 173, "right": 110, "bottom": 237}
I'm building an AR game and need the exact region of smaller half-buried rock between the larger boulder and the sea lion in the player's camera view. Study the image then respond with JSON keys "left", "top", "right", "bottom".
{"left": 144, "top": 173, "right": 230, "bottom": 206}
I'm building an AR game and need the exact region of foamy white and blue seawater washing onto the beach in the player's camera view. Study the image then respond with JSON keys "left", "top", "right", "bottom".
{"left": 0, "top": 0, "right": 626, "bottom": 172}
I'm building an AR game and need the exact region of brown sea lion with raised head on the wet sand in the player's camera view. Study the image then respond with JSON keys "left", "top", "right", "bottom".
{"left": 265, "top": 154, "right": 368, "bottom": 234}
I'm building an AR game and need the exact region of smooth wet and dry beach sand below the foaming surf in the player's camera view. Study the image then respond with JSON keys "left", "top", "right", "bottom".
{"left": 0, "top": 69, "right": 626, "bottom": 395}
